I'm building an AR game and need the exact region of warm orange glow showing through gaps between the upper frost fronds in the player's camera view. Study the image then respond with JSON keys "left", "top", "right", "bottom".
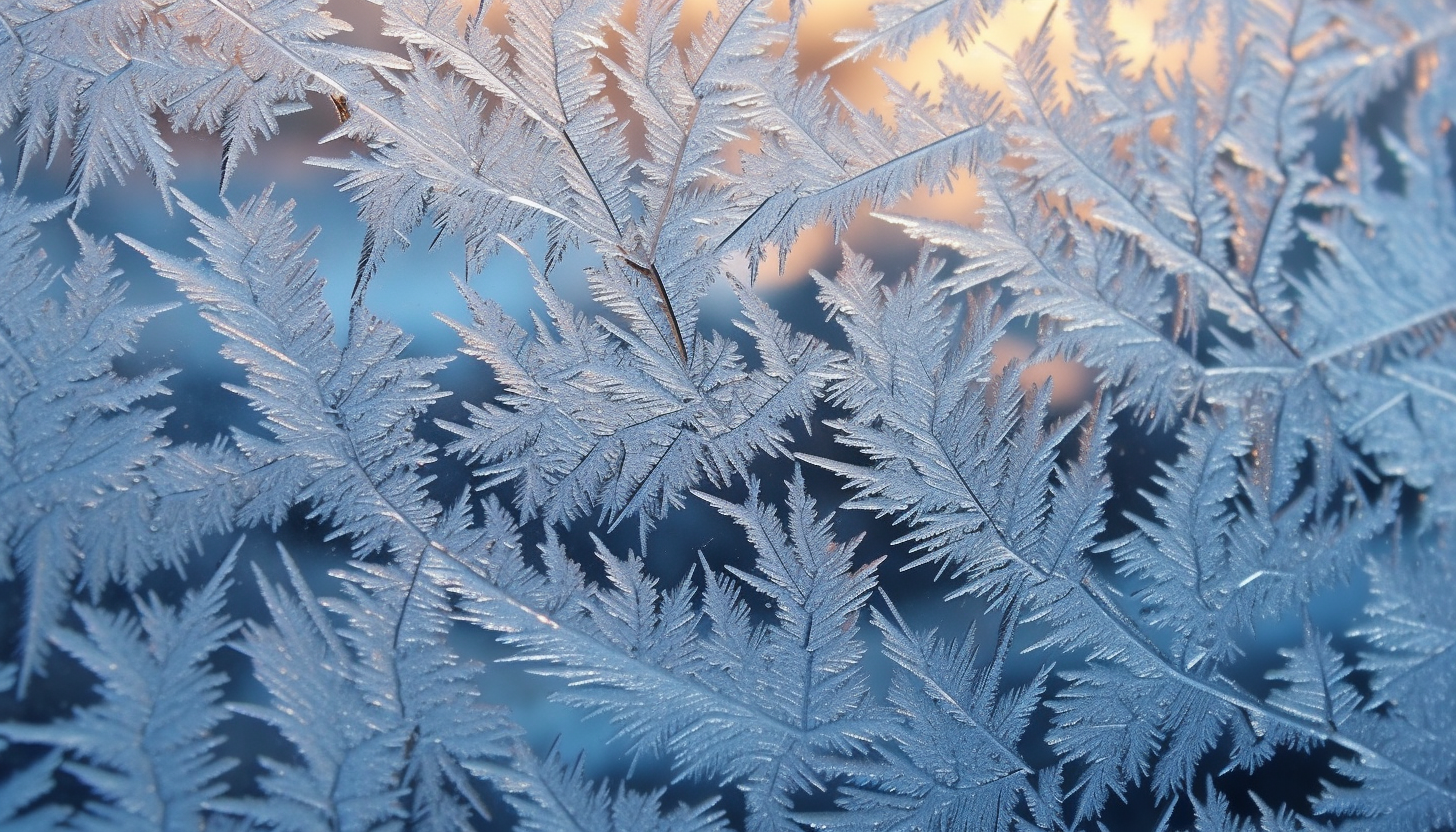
{"left": 422, "top": 0, "right": 1182, "bottom": 412}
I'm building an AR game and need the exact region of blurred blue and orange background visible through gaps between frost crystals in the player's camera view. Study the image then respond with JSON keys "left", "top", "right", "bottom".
{"left": 0, "top": 0, "right": 1363, "bottom": 829}
